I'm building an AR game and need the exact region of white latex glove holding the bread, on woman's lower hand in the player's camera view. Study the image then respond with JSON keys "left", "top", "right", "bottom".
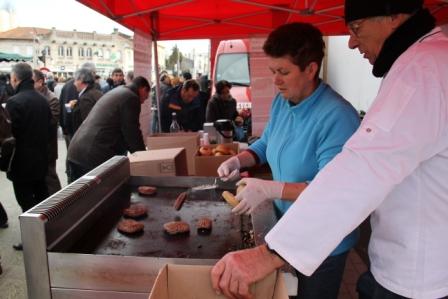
{"left": 232, "top": 178, "right": 285, "bottom": 215}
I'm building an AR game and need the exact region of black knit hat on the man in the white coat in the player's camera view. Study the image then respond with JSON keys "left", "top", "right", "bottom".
{"left": 345, "top": 0, "right": 423, "bottom": 23}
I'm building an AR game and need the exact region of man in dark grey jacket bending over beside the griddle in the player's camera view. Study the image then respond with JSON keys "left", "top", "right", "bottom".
{"left": 67, "top": 77, "right": 150, "bottom": 181}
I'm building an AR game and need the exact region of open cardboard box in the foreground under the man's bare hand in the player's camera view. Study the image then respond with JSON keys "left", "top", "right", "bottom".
{"left": 149, "top": 264, "right": 289, "bottom": 299}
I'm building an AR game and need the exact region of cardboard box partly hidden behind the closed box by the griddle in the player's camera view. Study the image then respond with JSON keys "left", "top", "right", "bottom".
{"left": 146, "top": 133, "right": 199, "bottom": 175}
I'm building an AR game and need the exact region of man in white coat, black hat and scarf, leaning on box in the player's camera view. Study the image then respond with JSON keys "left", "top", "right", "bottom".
{"left": 211, "top": 0, "right": 448, "bottom": 299}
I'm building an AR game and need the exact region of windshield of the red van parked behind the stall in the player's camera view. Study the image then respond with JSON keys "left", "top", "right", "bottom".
{"left": 215, "top": 53, "right": 250, "bottom": 86}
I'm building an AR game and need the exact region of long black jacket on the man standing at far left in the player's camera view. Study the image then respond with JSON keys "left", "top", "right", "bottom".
{"left": 6, "top": 80, "right": 52, "bottom": 182}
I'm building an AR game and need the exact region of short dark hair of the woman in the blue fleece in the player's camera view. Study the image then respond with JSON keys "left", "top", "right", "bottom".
{"left": 263, "top": 23, "right": 325, "bottom": 76}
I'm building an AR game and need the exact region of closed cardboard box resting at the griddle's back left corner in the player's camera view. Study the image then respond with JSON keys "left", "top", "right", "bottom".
{"left": 128, "top": 148, "right": 188, "bottom": 176}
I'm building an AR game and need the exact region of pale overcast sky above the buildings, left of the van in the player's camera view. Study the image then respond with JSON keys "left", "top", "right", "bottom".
{"left": 0, "top": 0, "right": 209, "bottom": 52}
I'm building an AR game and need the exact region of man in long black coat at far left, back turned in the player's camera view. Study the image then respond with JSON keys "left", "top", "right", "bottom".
{"left": 6, "top": 63, "right": 51, "bottom": 249}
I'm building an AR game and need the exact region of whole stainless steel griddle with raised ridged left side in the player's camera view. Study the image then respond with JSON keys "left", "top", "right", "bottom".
{"left": 19, "top": 156, "right": 275, "bottom": 299}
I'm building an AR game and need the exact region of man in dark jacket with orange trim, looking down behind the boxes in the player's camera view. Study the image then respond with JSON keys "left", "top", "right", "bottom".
{"left": 160, "top": 80, "right": 204, "bottom": 132}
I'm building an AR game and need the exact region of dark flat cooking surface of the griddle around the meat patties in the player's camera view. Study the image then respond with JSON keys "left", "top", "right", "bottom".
{"left": 93, "top": 186, "right": 250, "bottom": 259}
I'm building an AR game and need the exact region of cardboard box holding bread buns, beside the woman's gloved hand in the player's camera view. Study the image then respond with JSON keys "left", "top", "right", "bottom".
{"left": 194, "top": 143, "right": 239, "bottom": 177}
